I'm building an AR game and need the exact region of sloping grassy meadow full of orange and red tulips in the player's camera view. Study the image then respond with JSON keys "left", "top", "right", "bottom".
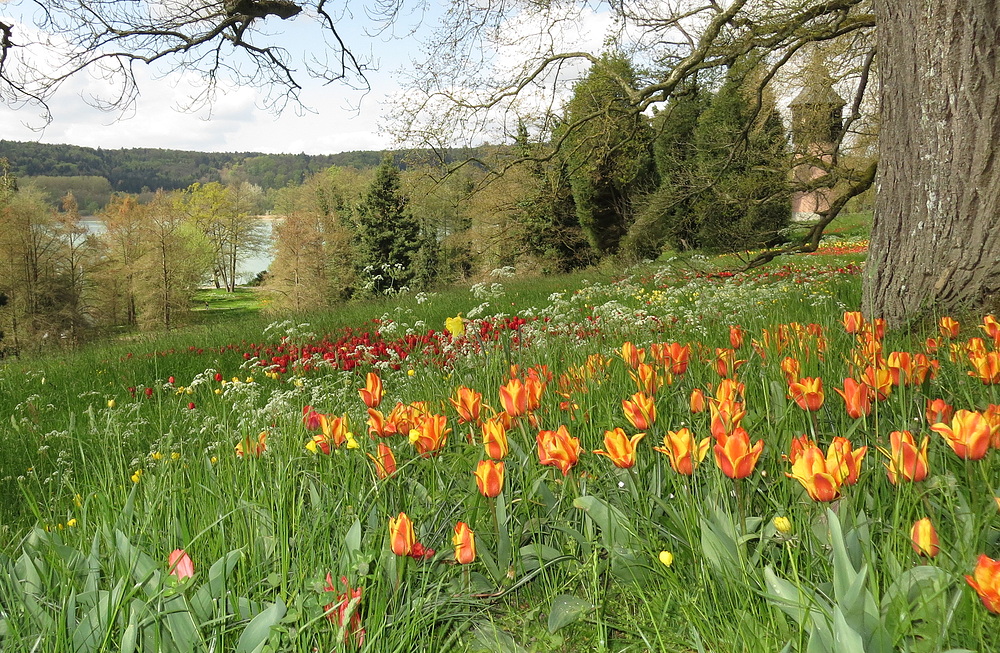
{"left": 0, "top": 236, "right": 1000, "bottom": 653}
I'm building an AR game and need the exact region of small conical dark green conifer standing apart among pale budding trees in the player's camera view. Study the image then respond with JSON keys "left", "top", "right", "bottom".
{"left": 354, "top": 156, "right": 422, "bottom": 295}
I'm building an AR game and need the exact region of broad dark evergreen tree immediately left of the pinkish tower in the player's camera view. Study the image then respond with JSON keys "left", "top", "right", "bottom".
{"left": 692, "top": 63, "right": 791, "bottom": 251}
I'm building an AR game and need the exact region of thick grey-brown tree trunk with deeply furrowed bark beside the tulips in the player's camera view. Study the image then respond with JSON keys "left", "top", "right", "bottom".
{"left": 863, "top": 0, "right": 1000, "bottom": 326}
